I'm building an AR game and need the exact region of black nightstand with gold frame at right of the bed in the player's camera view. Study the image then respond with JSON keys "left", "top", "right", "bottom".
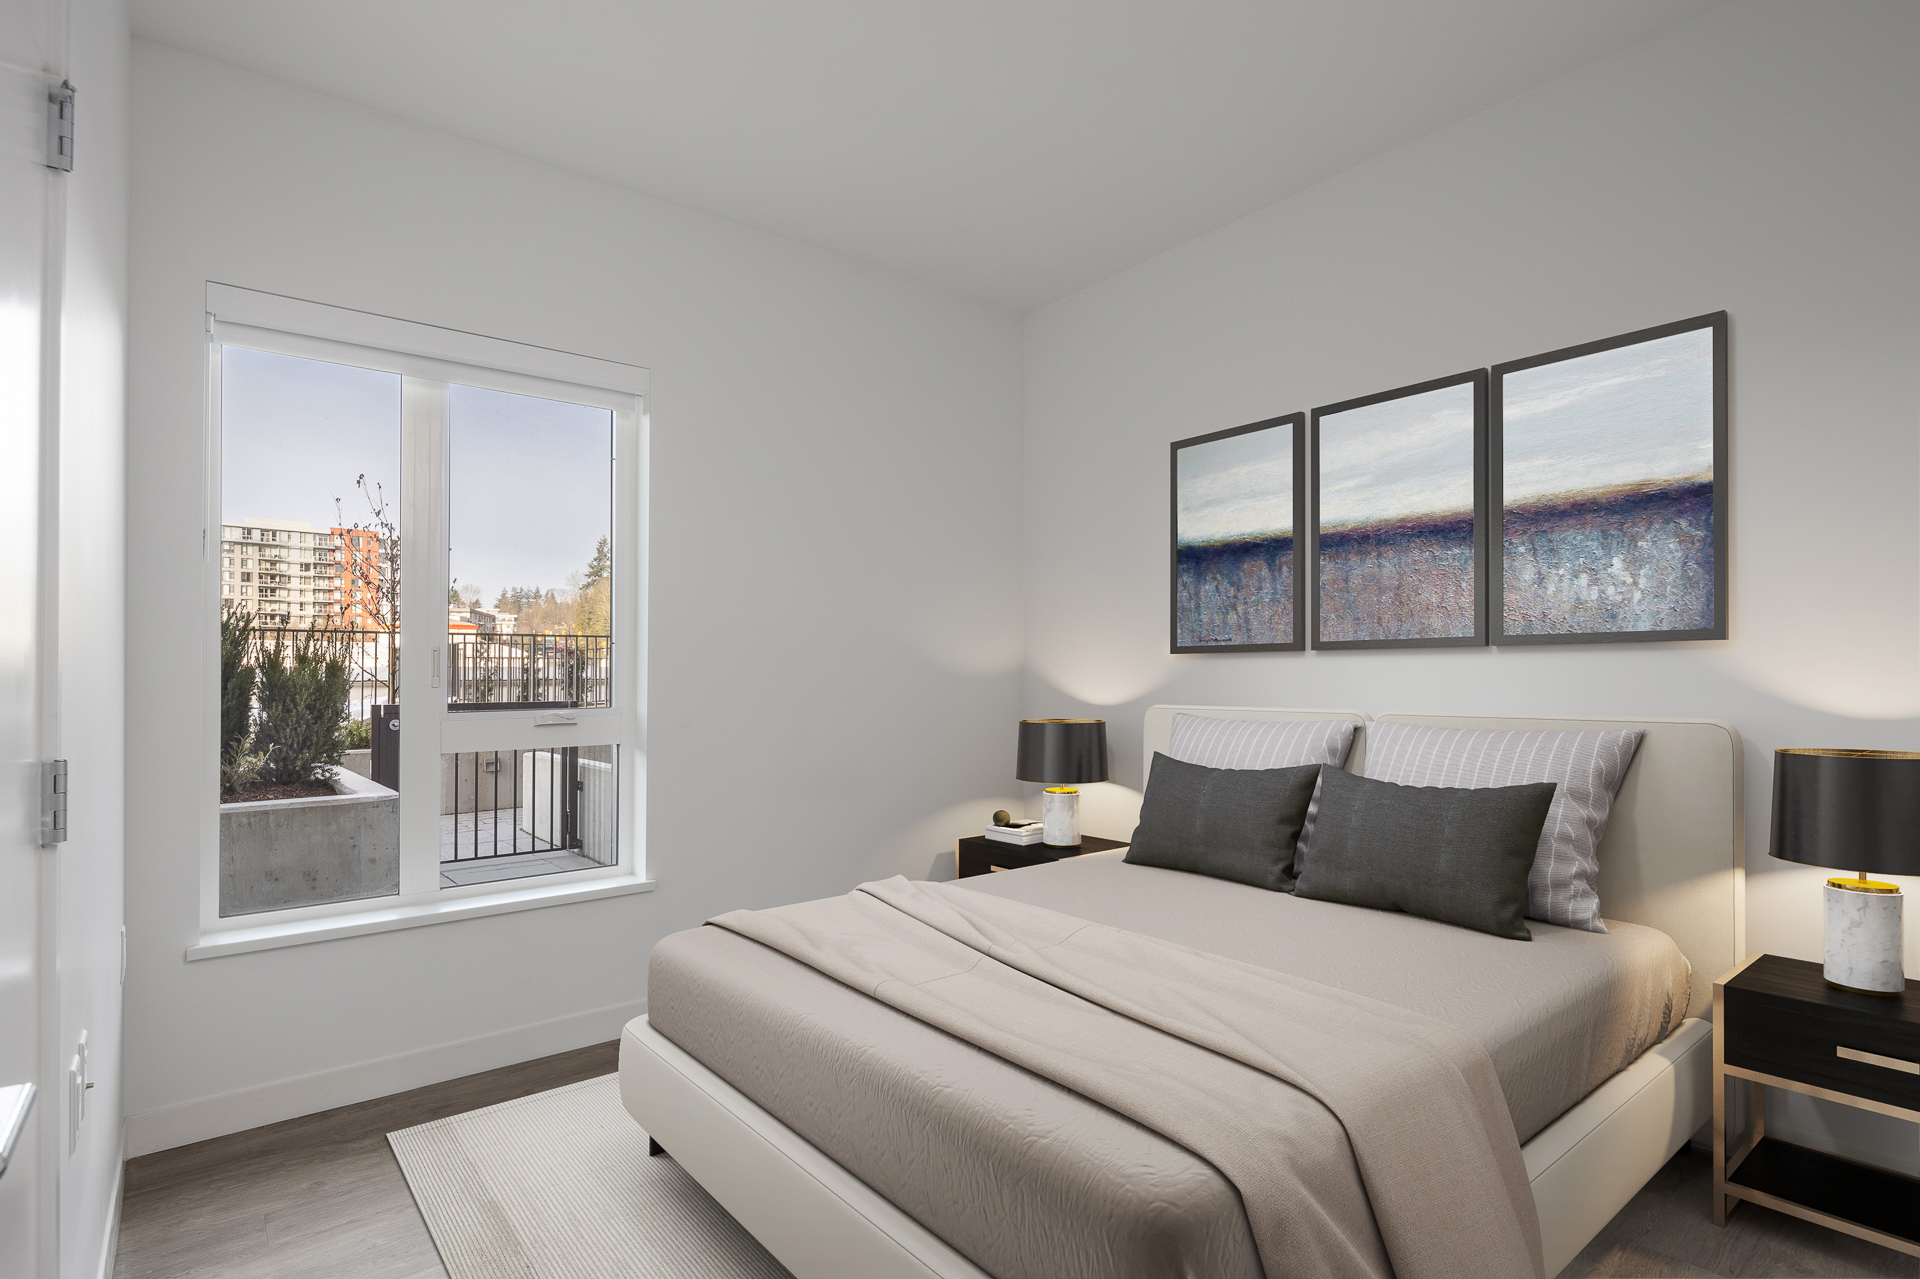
{"left": 1713, "top": 954, "right": 1920, "bottom": 1256}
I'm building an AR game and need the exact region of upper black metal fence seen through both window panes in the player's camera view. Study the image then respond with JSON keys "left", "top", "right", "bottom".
{"left": 253, "top": 626, "right": 612, "bottom": 720}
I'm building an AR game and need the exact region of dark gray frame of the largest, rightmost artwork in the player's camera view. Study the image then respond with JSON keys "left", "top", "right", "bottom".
{"left": 1486, "top": 311, "right": 1730, "bottom": 645}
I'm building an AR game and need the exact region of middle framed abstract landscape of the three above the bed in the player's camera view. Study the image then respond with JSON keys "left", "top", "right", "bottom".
{"left": 1309, "top": 369, "right": 1486, "bottom": 649}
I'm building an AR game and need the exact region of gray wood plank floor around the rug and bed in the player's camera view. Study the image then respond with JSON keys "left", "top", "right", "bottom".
{"left": 113, "top": 1043, "right": 1920, "bottom": 1279}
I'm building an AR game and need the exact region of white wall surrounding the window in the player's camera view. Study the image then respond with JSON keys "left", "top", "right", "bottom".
{"left": 127, "top": 42, "right": 1021, "bottom": 1152}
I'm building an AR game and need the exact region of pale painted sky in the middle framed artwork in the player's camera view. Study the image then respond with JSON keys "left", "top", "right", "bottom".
{"left": 1319, "top": 382, "right": 1473, "bottom": 528}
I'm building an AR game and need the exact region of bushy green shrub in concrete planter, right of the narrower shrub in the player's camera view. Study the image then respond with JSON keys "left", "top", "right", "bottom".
{"left": 253, "top": 630, "right": 351, "bottom": 784}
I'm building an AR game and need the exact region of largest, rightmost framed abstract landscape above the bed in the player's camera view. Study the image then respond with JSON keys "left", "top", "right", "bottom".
{"left": 1490, "top": 311, "right": 1726, "bottom": 643}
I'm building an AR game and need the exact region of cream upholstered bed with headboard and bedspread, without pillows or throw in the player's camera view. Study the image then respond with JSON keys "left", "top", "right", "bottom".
{"left": 620, "top": 707, "right": 1741, "bottom": 1279}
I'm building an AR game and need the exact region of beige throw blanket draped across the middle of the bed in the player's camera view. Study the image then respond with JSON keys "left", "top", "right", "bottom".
{"left": 706, "top": 878, "right": 1542, "bottom": 1279}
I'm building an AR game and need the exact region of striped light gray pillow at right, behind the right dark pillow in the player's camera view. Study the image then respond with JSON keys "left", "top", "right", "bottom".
{"left": 1367, "top": 724, "right": 1644, "bottom": 933}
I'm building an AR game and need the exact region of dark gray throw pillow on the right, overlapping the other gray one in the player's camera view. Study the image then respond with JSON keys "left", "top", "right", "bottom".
{"left": 1294, "top": 768, "right": 1555, "bottom": 941}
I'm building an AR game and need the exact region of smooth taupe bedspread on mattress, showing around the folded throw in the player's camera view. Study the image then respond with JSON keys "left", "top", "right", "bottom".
{"left": 647, "top": 853, "right": 1688, "bottom": 1279}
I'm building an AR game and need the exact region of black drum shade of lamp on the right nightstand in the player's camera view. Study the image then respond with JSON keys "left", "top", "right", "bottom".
{"left": 1766, "top": 749, "right": 1920, "bottom": 876}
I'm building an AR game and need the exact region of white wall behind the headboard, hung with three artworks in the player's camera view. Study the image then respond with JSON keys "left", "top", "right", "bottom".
{"left": 1021, "top": 0, "right": 1920, "bottom": 1171}
